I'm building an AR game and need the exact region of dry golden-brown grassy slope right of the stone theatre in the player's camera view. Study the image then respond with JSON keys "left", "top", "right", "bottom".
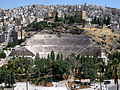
{"left": 82, "top": 28, "right": 120, "bottom": 49}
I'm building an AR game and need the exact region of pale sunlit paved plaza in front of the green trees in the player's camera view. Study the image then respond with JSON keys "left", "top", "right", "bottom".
{"left": 5, "top": 80, "right": 120, "bottom": 90}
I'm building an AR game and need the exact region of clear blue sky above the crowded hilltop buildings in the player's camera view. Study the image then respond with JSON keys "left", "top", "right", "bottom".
{"left": 0, "top": 0, "right": 120, "bottom": 9}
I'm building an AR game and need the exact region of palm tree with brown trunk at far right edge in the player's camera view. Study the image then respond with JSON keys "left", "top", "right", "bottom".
{"left": 110, "top": 52, "right": 120, "bottom": 90}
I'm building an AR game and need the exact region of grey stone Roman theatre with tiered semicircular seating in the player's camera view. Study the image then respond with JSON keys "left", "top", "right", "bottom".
{"left": 17, "top": 34, "right": 101, "bottom": 57}
